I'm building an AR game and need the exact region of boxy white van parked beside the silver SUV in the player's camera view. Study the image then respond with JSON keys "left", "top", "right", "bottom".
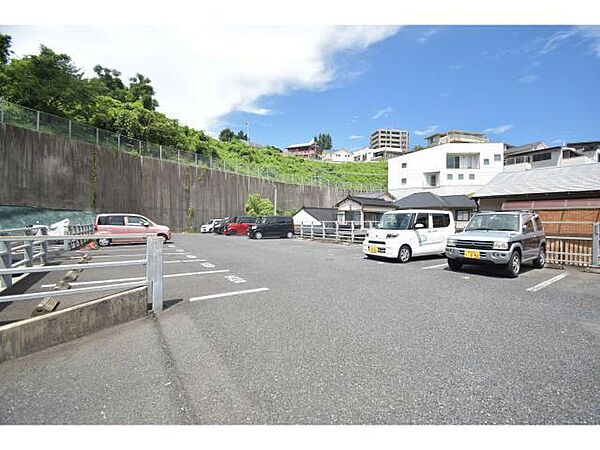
{"left": 363, "top": 209, "right": 456, "bottom": 263}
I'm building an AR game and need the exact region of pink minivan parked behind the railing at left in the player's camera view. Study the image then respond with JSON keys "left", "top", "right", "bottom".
{"left": 94, "top": 213, "right": 171, "bottom": 247}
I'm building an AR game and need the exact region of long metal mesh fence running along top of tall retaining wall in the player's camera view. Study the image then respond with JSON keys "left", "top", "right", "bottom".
{"left": 0, "top": 98, "right": 387, "bottom": 192}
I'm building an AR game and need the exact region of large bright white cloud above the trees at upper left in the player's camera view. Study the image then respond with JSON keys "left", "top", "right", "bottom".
{"left": 3, "top": 24, "right": 398, "bottom": 131}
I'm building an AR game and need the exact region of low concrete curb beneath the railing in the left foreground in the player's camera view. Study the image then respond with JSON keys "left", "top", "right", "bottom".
{"left": 0, "top": 286, "right": 148, "bottom": 363}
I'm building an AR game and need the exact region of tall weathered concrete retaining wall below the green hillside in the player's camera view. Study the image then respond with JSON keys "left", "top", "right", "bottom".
{"left": 0, "top": 125, "right": 346, "bottom": 231}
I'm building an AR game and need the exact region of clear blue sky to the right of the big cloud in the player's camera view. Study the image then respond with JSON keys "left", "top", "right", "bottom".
{"left": 222, "top": 26, "right": 600, "bottom": 149}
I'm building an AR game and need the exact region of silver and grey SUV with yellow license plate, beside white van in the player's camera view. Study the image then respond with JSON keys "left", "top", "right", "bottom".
{"left": 446, "top": 211, "right": 546, "bottom": 278}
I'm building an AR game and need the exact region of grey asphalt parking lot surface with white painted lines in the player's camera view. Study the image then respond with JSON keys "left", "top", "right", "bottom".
{"left": 0, "top": 234, "right": 600, "bottom": 424}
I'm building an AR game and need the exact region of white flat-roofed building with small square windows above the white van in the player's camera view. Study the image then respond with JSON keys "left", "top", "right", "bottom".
{"left": 388, "top": 143, "right": 505, "bottom": 198}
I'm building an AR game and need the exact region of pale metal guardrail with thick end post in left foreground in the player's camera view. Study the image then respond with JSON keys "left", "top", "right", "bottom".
{"left": 0, "top": 236, "right": 163, "bottom": 313}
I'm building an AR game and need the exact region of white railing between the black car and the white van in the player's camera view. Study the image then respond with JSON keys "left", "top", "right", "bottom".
{"left": 295, "top": 221, "right": 379, "bottom": 244}
